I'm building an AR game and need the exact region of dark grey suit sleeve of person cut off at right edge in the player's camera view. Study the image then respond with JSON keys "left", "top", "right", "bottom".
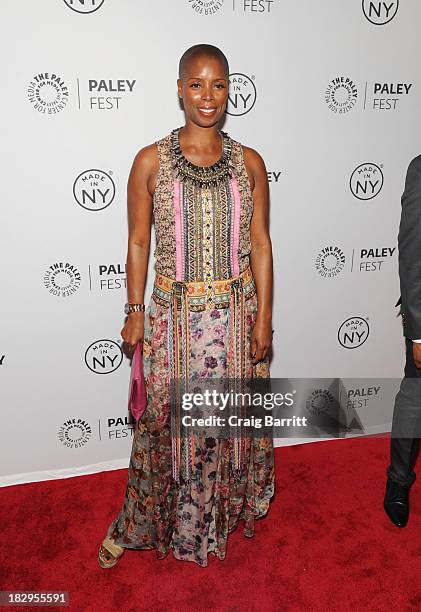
{"left": 398, "top": 155, "right": 421, "bottom": 338}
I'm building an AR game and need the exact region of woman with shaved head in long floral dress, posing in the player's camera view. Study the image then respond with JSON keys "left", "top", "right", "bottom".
{"left": 99, "top": 44, "right": 274, "bottom": 568}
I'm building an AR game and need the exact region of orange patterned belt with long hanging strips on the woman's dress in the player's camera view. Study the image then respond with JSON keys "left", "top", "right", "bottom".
{"left": 152, "top": 266, "right": 256, "bottom": 483}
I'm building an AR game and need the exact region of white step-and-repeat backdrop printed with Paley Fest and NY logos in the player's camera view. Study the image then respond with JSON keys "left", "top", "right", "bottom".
{"left": 0, "top": 0, "right": 421, "bottom": 486}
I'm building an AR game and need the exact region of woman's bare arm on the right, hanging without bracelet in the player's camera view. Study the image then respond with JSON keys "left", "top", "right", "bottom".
{"left": 243, "top": 147, "right": 273, "bottom": 364}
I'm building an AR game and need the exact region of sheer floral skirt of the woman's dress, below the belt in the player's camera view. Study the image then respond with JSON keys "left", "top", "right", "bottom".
{"left": 107, "top": 295, "right": 275, "bottom": 567}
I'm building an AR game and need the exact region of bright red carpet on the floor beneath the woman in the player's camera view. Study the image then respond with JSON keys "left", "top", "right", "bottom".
{"left": 0, "top": 438, "right": 421, "bottom": 612}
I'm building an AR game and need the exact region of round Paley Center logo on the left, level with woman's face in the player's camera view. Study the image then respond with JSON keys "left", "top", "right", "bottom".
{"left": 27, "top": 72, "right": 69, "bottom": 115}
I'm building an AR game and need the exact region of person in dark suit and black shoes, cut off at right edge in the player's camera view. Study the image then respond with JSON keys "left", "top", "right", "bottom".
{"left": 384, "top": 155, "right": 421, "bottom": 527}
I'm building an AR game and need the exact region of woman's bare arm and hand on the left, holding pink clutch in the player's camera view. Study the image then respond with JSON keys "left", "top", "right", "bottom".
{"left": 121, "top": 144, "right": 159, "bottom": 348}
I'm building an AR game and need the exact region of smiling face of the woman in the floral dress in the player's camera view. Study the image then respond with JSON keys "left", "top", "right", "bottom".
{"left": 177, "top": 56, "right": 228, "bottom": 127}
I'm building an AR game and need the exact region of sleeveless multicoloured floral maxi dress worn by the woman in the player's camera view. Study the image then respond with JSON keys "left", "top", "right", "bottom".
{"left": 107, "top": 128, "right": 275, "bottom": 567}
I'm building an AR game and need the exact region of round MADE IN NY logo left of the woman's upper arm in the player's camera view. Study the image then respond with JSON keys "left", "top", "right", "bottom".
{"left": 73, "top": 168, "right": 115, "bottom": 211}
